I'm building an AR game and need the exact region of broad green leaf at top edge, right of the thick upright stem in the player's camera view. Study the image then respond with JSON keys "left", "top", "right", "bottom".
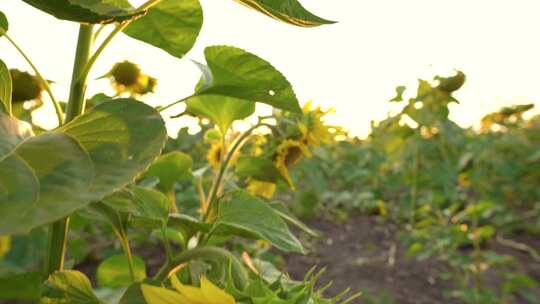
{"left": 124, "top": 0, "right": 203, "bottom": 58}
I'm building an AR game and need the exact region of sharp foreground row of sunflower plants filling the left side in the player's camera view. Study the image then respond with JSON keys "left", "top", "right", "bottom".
{"left": 0, "top": 0, "right": 358, "bottom": 304}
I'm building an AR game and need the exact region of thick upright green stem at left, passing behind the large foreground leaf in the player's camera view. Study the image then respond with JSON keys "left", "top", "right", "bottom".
{"left": 44, "top": 24, "right": 93, "bottom": 277}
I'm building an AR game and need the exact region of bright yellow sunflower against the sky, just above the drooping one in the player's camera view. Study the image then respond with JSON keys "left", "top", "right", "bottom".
{"left": 298, "top": 101, "right": 334, "bottom": 147}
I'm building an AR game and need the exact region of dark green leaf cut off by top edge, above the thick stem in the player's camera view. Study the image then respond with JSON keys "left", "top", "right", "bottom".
{"left": 23, "top": 0, "right": 145, "bottom": 23}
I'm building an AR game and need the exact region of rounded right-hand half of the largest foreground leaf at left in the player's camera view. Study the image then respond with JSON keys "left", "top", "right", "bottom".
{"left": 60, "top": 99, "right": 167, "bottom": 200}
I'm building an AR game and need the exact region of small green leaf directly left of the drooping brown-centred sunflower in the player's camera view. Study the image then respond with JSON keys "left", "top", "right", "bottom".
{"left": 235, "top": 156, "right": 284, "bottom": 183}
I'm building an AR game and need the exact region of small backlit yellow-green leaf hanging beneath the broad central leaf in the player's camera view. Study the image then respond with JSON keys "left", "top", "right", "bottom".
{"left": 186, "top": 95, "right": 255, "bottom": 134}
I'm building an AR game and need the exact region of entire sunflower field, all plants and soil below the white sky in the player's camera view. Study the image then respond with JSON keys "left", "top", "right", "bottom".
{"left": 0, "top": 0, "right": 540, "bottom": 304}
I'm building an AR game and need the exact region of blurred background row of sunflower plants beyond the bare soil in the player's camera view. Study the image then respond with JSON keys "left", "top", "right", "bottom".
{"left": 292, "top": 72, "right": 540, "bottom": 303}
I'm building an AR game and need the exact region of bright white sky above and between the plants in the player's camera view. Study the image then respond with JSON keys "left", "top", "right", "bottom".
{"left": 0, "top": 0, "right": 540, "bottom": 135}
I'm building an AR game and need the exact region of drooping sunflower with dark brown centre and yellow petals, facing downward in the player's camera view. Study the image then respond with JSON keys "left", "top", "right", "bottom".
{"left": 275, "top": 139, "right": 312, "bottom": 190}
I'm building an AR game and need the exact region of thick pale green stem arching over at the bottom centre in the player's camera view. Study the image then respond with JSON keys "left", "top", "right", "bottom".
{"left": 154, "top": 246, "right": 248, "bottom": 290}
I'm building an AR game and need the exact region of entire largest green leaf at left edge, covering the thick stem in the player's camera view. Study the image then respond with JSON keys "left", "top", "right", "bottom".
{"left": 0, "top": 100, "right": 166, "bottom": 235}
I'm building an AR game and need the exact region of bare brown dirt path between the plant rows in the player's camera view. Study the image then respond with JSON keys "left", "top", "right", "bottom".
{"left": 286, "top": 216, "right": 540, "bottom": 304}
